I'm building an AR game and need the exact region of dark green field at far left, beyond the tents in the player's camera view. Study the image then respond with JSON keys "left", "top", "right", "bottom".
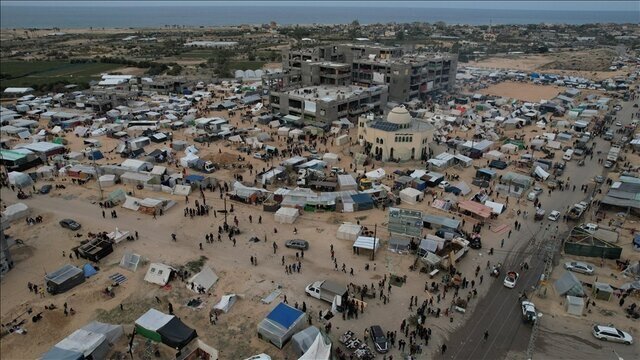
{"left": 0, "top": 61, "right": 123, "bottom": 88}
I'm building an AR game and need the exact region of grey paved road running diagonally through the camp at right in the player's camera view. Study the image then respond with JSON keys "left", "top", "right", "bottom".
{"left": 445, "top": 97, "right": 637, "bottom": 360}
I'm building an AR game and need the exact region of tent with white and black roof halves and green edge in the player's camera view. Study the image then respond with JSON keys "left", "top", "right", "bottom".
{"left": 135, "top": 309, "right": 198, "bottom": 349}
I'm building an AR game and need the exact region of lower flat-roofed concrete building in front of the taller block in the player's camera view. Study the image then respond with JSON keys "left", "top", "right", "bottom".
{"left": 269, "top": 85, "right": 388, "bottom": 124}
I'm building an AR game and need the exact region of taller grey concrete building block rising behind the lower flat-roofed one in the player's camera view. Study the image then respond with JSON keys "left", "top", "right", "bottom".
{"left": 265, "top": 44, "right": 458, "bottom": 103}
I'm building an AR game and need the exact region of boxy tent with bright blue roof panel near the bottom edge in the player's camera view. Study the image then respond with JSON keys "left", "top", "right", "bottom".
{"left": 258, "top": 303, "right": 306, "bottom": 349}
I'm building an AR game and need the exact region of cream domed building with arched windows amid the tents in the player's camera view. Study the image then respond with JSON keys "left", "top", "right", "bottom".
{"left": 358, "top": 106, "right": 434, "bottom": 161}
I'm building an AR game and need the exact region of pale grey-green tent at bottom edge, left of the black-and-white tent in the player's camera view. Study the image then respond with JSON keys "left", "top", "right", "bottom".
{"left": 41, "top": 321, "right": 124, "bottom": 360}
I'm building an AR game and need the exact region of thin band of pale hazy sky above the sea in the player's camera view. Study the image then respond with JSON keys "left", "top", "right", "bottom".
{"left": 5, "top": 0, "right": 640, "bottom": 11}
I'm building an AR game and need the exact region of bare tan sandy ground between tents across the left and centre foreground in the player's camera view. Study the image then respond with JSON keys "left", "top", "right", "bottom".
{"left": 0, "top": 92, "right": 636, "bottom": 359}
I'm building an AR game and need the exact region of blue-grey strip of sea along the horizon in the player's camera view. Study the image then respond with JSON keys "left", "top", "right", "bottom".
{"left": 0, "top": 1, "right": 639, "bottom": 29}
